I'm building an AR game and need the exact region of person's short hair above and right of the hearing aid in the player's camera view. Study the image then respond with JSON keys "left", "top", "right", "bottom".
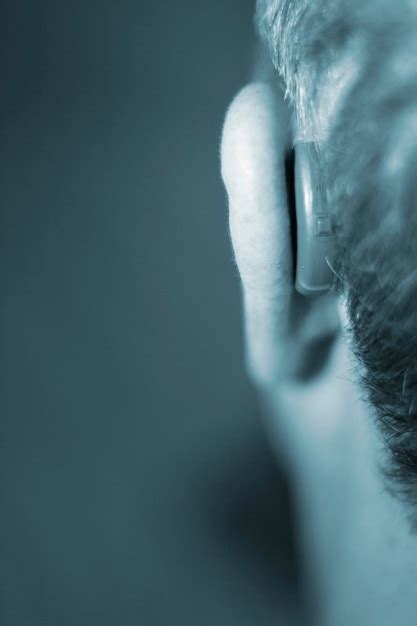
{"left": 256, "top": 0, "right": 417, "bottom": 523}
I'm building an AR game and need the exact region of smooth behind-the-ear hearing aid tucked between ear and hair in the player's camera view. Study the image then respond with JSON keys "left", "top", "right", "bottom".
{"left": 294, "top": 142, "right": 335, "bottom": 296}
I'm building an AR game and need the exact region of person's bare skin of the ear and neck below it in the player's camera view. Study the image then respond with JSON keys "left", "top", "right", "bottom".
{"left": 221, "top": 82, "right": 417, "bottom": 626}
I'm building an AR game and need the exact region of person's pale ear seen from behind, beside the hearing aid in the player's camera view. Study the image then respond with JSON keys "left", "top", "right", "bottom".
{"left": 221, "top": 83, "right": 339, "bottom": 386}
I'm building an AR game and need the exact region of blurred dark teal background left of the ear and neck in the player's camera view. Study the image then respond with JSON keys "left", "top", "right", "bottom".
{"left": 0, "top": 0, "right": 299, "bottom": 626}
